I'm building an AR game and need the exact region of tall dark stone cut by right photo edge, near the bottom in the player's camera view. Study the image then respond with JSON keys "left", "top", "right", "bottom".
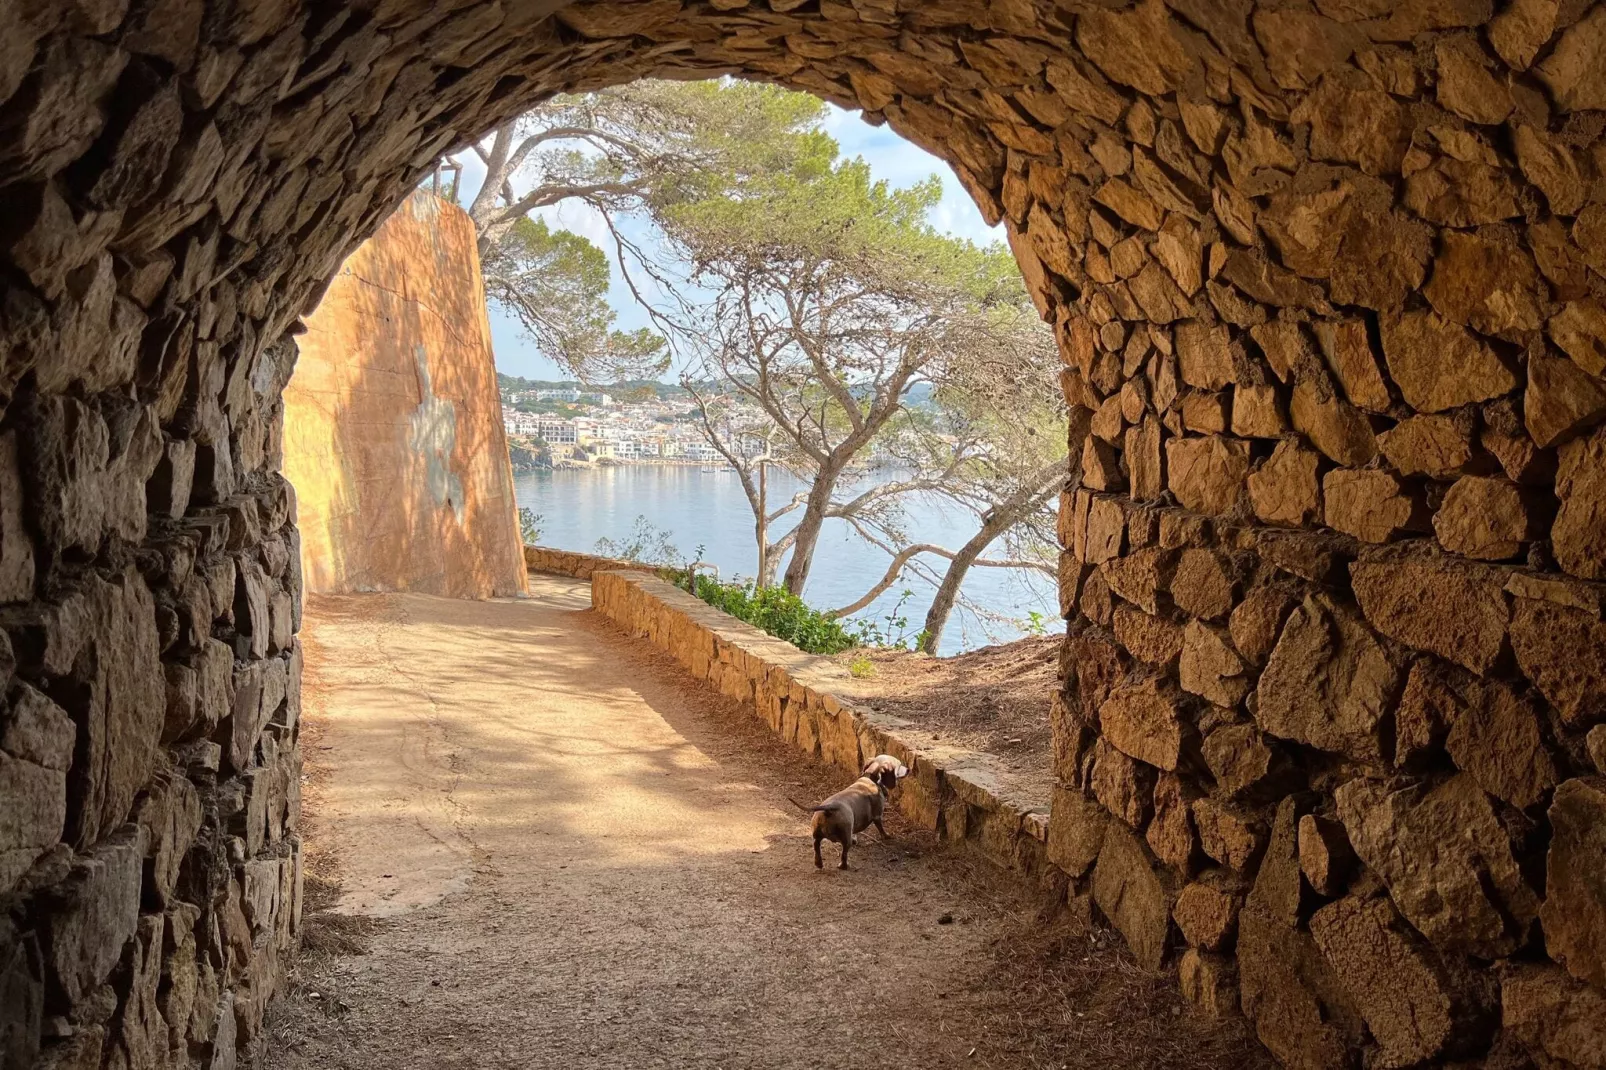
{"left": 1539, "top": 776, "right": 1606, "bottom": 990}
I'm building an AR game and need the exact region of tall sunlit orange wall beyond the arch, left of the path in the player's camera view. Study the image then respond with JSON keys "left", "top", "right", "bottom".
{"left": 284, "top": 191, "right": 525, "bottom": 598}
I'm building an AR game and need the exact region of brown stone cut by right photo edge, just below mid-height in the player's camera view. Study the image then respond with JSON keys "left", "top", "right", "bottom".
{"left": 1511, "top": 598, "right": 1606, "bottom": 728}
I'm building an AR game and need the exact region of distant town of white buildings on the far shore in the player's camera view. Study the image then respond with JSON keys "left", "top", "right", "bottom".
{"left": 498, "top": 376, "right": 763, "bottom": 469}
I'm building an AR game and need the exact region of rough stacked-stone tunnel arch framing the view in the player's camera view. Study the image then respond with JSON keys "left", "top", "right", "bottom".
{"left": 0, "top": 0, "right": 1606, "bottom": 1067}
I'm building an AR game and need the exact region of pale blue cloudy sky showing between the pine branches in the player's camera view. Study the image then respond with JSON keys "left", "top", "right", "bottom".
{"left": 458, "top": 93, "right": 1004, "bottom": 379}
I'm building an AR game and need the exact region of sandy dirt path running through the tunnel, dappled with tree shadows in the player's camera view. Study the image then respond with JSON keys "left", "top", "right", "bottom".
{"left": 268, "top": 577, "right": 1265, "bottom": 1070}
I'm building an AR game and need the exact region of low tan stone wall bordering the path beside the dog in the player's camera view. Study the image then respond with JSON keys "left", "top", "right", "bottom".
{"left": 594, "top": 565, "right": 1049, "bottom": 877}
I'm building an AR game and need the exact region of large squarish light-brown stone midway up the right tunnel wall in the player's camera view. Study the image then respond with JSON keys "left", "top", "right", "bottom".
{"left": 1254, "top": 594, "right": 1400, "bottom": 763}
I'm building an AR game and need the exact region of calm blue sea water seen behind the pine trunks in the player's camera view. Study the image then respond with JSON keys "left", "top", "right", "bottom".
{"left": 514, "top": 464, "right": 1063, "bottom": 654}
